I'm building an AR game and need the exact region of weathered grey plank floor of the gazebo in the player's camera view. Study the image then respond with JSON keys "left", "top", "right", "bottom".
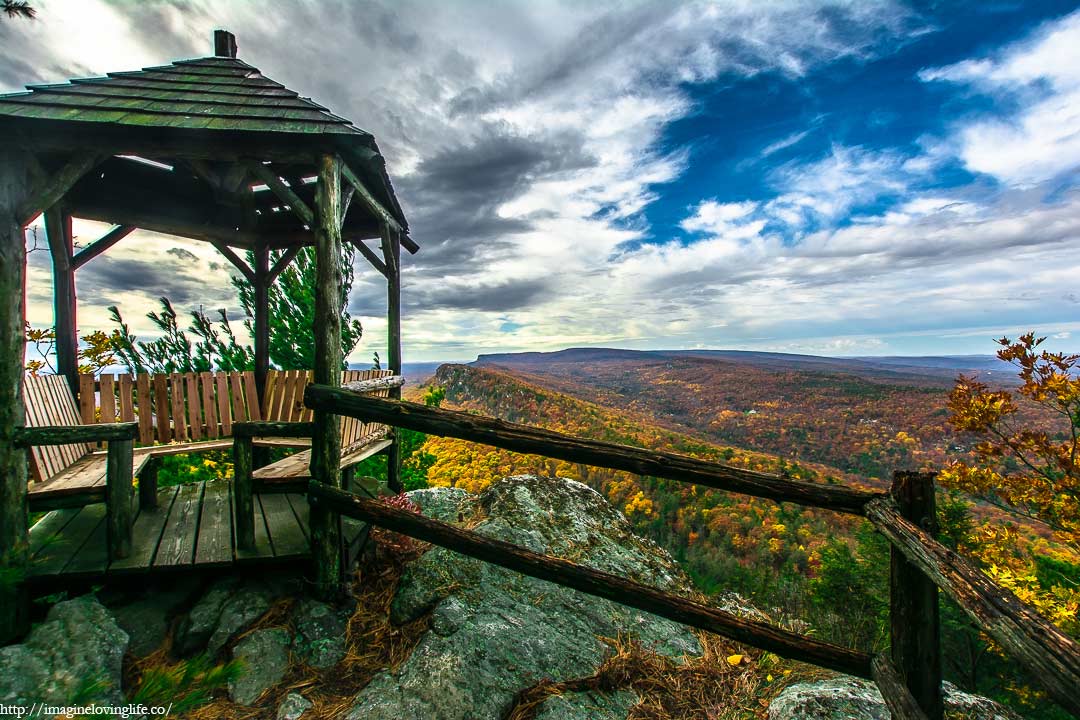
{"left": 29, "top": 480, "right": 366, "bottom": 580}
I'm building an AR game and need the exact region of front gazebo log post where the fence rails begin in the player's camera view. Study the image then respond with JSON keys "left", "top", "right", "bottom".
{"left": 310, "top": 155, "right": 341, "bottom": 600}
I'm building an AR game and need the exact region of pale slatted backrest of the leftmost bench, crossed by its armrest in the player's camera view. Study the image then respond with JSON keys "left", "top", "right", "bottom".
{"left": 23, "top": 375, "right": 93, "bottom": 483}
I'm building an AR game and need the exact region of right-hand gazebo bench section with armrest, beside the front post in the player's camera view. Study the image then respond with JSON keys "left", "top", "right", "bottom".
{"left": 233, "top": 370, "right": 404, "bottom": 547}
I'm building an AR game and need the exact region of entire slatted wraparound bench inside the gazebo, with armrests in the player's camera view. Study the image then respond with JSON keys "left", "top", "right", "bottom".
{"left": 24, "top": 370, "right": 401, "bottom": 557}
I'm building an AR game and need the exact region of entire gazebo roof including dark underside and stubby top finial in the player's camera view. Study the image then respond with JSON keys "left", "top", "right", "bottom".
{"left": 0, "top": 30, "right": 408, "bottom": 243}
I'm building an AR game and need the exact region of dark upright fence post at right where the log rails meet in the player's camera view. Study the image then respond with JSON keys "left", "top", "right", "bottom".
{"left": 889, "top": 472, "right": 944, "bottom": 720}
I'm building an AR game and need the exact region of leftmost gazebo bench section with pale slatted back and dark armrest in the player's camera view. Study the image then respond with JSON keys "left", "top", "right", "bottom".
{"left": 19, "top": 375, "right": 149, "bottom": 558}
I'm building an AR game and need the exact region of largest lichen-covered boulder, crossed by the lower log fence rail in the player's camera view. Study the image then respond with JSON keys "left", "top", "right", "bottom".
{"left": 346, "top": 476, "right": 701, "bottom": 720}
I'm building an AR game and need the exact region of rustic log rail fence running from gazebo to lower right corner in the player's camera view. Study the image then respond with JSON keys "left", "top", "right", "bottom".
{"left": 303, "top": 384, "right": 1080, "bottom": 720}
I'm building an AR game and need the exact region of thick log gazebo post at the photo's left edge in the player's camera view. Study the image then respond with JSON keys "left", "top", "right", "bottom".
{"left": 0, "top": 145, "right": 29, "bottom": 644}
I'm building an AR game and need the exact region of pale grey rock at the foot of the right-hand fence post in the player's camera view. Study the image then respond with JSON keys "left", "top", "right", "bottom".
{"left": 769, "top": 678, "right": 1023, "bottom": 720}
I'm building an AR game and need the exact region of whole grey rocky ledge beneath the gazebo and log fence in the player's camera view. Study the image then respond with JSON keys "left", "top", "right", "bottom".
{"left": 0, "top": 476, "right": 1018, "bottom": 720}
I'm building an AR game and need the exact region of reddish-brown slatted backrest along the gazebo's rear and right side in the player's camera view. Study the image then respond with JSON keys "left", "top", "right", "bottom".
{"left": 79, "top": 370, "right": 392, "bottom": 447}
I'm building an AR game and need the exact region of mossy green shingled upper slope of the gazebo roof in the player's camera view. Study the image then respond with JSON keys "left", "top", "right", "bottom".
{"left": 0, "top": 56, "right": 369, "bottom": 136}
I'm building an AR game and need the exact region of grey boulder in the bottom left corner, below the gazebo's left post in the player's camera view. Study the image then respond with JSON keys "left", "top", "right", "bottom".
{"left": 0, "top": 595, "right": 129, "bottom": 708}
